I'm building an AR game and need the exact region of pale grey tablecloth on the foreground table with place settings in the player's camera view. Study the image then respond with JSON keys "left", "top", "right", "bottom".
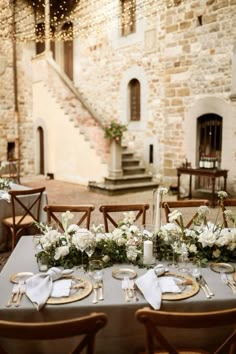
{"left": 0, "top": 236, "right": 236, "bottom": 354}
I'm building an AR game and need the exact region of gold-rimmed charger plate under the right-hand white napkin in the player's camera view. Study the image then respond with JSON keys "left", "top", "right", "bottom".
{"left": 162, "top": 273, "right": 200, "bottom": 301}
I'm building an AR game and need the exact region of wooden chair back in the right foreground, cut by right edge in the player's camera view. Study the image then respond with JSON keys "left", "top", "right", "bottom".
{"left": 135, "top": 307, "right": 236, "bottom": 354}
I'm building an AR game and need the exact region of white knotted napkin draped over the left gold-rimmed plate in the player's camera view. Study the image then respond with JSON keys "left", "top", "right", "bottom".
{"left": 26, "top": 267, "right": 73, "bottom": 310}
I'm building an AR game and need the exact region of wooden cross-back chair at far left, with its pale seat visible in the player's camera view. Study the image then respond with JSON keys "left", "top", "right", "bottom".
{"left": 2, "top": 187, "right": 46, "bottom": 250}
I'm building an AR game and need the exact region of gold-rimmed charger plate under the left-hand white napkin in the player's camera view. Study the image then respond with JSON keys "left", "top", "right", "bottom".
{"left": 47, "top": 276, "right": 93, "bottom": 305}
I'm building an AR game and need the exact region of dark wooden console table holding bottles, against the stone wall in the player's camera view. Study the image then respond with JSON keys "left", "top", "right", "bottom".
{"left": 177, "top": 167, "right": 228, "bottom": 206}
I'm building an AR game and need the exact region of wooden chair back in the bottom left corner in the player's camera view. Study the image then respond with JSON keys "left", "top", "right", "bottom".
{"left": 0, "top": 312, "right": 108, "bottom": 354}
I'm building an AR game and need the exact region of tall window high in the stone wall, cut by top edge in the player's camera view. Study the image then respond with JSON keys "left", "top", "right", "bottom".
{"left": 121, "top": 0, "right": 136, "bottom": 36}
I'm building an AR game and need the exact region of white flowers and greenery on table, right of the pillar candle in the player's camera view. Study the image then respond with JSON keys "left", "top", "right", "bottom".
{"left": 157, "top": 191, "right": 236, "bottom": 265}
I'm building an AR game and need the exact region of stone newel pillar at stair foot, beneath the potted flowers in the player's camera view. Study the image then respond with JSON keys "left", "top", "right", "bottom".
{"left": 109, "top": 139, "right": 123, "bottom": 178}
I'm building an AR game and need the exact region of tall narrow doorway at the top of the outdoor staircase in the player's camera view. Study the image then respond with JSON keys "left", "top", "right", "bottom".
{"left": 62, "top": 22, "right": 74, "bottom": 81}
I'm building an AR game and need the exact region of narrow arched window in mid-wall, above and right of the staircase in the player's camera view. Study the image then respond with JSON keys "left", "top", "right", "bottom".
{"left": 129, "top": 79, "right": 141, "bottom": 121}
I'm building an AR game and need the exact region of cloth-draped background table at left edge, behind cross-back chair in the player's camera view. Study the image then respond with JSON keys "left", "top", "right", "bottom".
{"left": 0, "top": 183, "right": 47, "bottom": 252}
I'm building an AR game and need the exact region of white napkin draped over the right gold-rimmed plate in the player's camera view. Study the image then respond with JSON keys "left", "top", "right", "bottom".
{"left": 135, "top": 269, "right": 181, "bottom": 310}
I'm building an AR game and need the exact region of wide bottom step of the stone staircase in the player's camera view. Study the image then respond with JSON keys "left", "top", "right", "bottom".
{"left": 88, "top": 182, "right": 159, "bottom": 195}
